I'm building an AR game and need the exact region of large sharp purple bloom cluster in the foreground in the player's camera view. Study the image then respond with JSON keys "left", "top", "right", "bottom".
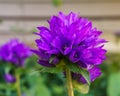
{"left": 34, "top": 12, "right": 106, "bottom": 82}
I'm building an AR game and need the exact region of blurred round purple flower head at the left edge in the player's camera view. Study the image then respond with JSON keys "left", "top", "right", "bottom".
{"left": 0, "top": 39, "right": 31, "bottom": 67}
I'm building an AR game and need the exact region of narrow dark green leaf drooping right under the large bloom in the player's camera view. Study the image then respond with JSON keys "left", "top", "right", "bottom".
{"left": 65, "top": 59, "right": 90, "bottom": 85}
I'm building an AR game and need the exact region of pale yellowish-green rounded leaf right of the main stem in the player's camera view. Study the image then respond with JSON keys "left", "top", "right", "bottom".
{"left": 73, "top": 81, "right": 89, "bottom": 94}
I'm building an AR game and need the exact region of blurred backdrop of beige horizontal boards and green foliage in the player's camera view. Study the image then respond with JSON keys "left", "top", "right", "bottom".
{"left": 0, "top": 0, "right": 120, "bottom": 96}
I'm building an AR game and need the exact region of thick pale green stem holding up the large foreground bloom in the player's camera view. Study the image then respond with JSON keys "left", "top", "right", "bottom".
{"left": 66, "top": 68, "right": 74, "bottom": 96}
